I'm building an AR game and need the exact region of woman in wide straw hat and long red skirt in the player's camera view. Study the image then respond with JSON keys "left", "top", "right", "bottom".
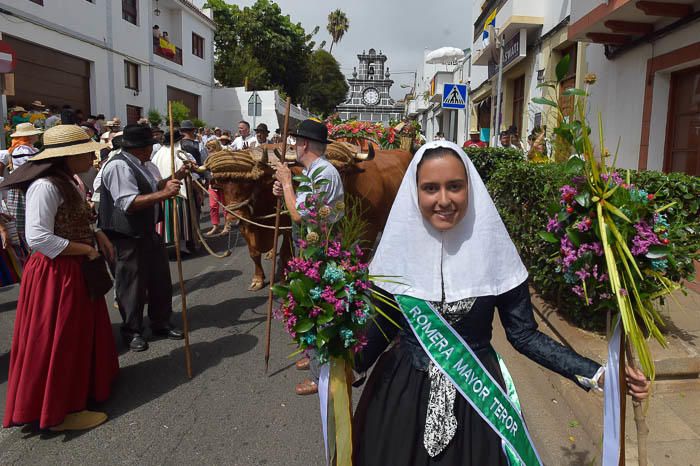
{"left": 0, "top": 125, "right": 119, "bottom": 431}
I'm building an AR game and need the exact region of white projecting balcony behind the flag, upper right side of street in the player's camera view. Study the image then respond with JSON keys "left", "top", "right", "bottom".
{"left": 472, "top": 0, "right": 546, "bottom": 66}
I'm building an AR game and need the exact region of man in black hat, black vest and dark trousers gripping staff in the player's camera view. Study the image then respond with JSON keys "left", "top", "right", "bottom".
{"left": 98, "top": 125, "right": 187, "bottom": 351}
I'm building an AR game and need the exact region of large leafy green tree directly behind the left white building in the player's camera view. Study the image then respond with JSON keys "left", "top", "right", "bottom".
{"left": 206, "top": 0, "right": 315, "bottom": 100}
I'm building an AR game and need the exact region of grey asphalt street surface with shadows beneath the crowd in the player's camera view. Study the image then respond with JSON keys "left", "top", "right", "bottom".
{"left": 0, "top": 224, "right": 596, "bottom": 466}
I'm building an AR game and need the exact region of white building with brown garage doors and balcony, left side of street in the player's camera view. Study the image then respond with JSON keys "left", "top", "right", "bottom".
{"left": 0, "top": 0, "right": 309, "bottom": 137}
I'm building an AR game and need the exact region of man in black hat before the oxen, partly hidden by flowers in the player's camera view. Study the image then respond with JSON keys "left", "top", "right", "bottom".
{"left": 272, "top": 119, "right": 344, "bottom": 395}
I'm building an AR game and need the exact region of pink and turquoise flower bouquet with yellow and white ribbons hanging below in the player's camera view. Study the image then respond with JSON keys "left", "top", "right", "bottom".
{"left": 273, "top": 170, "right": 391, "bottom": 465}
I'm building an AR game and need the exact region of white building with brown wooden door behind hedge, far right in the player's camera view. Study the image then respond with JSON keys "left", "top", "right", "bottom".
{"left": 568, "top": 0, "right": 700, "bottom": 176}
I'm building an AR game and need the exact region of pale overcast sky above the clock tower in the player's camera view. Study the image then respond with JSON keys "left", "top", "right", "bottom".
{"left": 229, "top": 0, "right": 472, "bottom": 99}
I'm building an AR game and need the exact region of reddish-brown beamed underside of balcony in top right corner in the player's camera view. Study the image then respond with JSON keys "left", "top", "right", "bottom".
{"left": 569, "top": 0, "right": 698, "bottom": 48}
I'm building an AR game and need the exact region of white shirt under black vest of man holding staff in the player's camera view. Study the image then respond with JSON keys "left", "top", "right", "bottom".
{"left": 101, "top": 151, "right": 158, "bottom": 212}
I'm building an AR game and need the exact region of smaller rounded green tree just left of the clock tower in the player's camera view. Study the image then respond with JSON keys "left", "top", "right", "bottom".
{"left": 303, "top": 50, "right": 349, "bottom": 115}
